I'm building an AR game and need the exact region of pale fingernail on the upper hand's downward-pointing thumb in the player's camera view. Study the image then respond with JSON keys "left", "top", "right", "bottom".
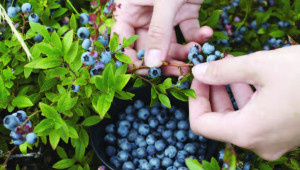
{"left": 145, "top": 49, "right": 162, "bottom": 67}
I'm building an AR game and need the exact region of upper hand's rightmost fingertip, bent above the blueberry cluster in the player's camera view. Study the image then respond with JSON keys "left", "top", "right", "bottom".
{"left": 180, "top": 18, "right": 213, "bottom": 44}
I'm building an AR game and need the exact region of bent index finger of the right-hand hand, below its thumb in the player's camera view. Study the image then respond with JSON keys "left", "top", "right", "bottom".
{"left": 189, "top": 79, "right": 239, "bottom": 142}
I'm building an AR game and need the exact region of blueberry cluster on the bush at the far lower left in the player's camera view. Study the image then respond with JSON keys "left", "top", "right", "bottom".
{"left": 3, "top": 110, "right": 37, "bottom": 145}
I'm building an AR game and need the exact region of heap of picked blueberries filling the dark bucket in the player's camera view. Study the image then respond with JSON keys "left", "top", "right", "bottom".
{"left": 104, "top": 100, "right": 207, "bottom": 170}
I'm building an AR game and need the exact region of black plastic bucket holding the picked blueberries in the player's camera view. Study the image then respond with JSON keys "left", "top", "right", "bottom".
{"left": 90, "top": 87, "right": 219, "bottom": 170}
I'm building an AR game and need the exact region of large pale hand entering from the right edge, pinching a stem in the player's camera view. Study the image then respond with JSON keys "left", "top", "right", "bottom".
{"left": 189, "top": 45, "right": 300, "bottom": 160}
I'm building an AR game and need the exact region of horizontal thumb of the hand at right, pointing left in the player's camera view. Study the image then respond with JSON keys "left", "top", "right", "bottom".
{"left": 193, "top": 53, "right": 263, "bottom": 85}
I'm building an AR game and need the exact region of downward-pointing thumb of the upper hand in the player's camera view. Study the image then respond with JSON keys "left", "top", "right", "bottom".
{"left": 145, "top": 0, "right": 184, "bottom": 67}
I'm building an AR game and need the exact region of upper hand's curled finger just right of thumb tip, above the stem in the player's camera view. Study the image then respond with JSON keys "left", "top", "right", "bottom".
{"left": 168, "top": 42, "right": 201, "bottom": 61}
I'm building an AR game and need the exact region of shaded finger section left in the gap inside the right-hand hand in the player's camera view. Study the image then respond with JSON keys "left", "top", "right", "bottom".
{"left": 210, "top": 86, "right": 234, "bottom": 113}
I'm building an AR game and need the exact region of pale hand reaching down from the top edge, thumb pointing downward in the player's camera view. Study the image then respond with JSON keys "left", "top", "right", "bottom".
{"left": 112, "top": 0, "right": 213, "bottom": 75}
